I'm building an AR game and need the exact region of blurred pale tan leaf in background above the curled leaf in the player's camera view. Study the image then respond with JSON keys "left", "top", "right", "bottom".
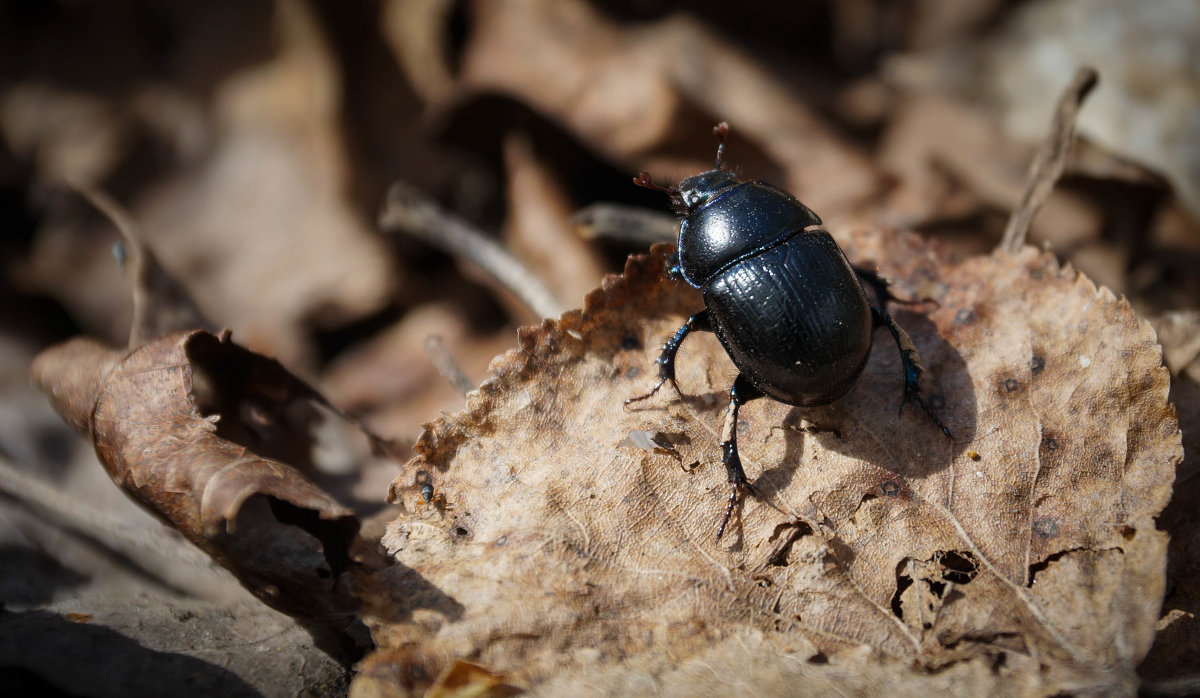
{"left": 120, "top": 0, "right": 395, "bottom": 367}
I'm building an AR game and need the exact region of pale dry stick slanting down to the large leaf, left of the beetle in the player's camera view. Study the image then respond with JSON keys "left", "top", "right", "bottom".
{"left": 379, "top": 182, "right": 566, "bottom": 318}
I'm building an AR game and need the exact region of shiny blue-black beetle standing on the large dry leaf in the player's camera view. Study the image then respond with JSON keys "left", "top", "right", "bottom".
{"left": 625, "top": 121, "right": 950, "bottom": 540}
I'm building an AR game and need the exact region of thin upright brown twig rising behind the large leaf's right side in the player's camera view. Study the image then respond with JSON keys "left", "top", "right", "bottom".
{"left": 997, "top": 67, "right": 1099, "bottom": 254}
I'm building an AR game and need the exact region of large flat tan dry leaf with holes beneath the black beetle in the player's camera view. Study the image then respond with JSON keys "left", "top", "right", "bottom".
{"left": 368, "top": 233, "right": 1181, "bottom": 694}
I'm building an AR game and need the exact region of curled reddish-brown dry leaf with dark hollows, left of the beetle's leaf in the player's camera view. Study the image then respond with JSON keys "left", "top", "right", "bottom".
{"left": 32, "top": 331, "right": 367, "bottom": 626}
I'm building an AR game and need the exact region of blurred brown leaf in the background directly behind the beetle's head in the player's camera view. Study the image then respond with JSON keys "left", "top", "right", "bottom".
{"left": 458, "top": 0, "right": 881, "bottom": 213}
